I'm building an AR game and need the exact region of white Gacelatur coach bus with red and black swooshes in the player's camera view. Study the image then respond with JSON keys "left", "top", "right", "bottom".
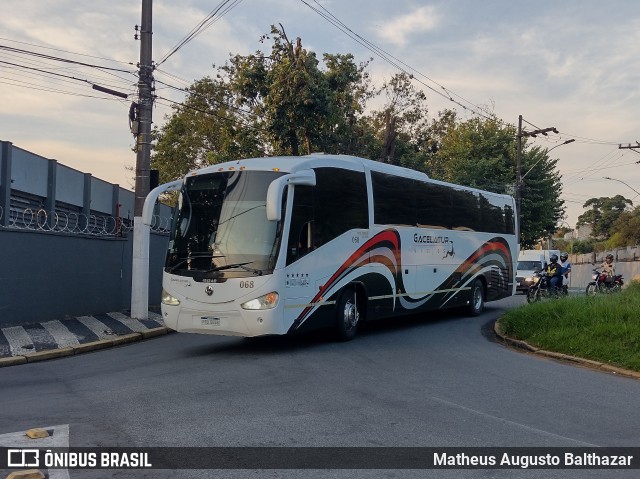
{"left": 147, "top": 154, "right": 518, "bottom": 340}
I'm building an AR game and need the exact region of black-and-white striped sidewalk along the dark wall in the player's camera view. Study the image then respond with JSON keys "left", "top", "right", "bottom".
{"left": 0, "top": 311, "right": 168, "bottom": 367}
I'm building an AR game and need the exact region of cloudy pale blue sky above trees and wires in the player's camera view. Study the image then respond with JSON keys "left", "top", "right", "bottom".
{"left": 0, "top": 0, "right": 640, "bottom": 227}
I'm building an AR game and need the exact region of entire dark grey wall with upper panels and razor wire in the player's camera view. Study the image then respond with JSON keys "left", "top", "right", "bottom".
{"left": 0, "top": 140, "right": 171, "bottom": 327}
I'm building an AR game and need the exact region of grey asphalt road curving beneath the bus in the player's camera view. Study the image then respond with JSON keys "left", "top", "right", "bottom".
{"left": 0, "top": 296, "right": 640, "bottom": 479}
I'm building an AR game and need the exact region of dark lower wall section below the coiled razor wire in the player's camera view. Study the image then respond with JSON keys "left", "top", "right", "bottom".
{"left": 0, "top": 230, "right": 168, "bottom": 327}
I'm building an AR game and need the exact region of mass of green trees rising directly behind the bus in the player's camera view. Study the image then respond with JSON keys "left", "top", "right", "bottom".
{"left": 152, "top": 26, "right": 563, "bottom": 248}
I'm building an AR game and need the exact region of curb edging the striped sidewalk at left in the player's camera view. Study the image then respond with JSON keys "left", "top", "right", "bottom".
{"left": 0, "top": 326, "right": 171, "bottom": 368}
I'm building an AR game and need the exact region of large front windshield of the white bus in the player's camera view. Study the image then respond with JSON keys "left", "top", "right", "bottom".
{"left": 165, "top": 170, "right": 283, "bottom": 279}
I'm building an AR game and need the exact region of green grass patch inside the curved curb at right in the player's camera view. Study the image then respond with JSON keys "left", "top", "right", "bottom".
{"left": 498, "top": 282, "right": 640, "bottom": 371}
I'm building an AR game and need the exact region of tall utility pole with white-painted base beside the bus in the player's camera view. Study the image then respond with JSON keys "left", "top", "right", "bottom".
{"left": 131, "top": 0, "right": 153, "bottom": 319}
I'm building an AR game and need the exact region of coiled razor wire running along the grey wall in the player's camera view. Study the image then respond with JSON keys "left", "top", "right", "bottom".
{"left": 0, "top": 206, "right": 171, "bottom": 237}
